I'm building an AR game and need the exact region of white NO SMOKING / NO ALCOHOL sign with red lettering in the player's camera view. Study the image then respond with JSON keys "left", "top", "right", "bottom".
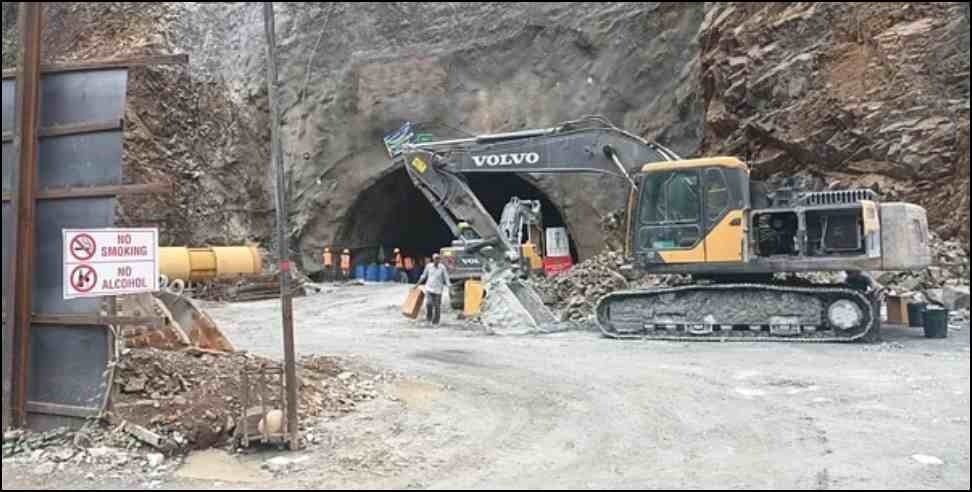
{"left": 63, "top": 229, "right": 159, "bottom": 299}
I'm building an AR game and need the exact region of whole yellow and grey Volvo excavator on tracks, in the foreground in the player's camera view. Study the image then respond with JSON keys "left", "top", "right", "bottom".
{"left": 401, "top": 117, "right": 931, "bottom": 342}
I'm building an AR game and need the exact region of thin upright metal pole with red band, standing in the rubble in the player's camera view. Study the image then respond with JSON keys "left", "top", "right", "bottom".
{"left": 263, "top": 2, "right": 300, "bottom": 451}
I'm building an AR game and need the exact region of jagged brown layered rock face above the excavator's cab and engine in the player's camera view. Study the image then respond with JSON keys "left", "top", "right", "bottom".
{"left": 702, "top": 2, "right": 969, "bottom": 243}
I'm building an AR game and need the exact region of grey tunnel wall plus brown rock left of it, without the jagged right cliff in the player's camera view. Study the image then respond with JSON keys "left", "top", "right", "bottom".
{"left": 4, "top": 2, "right": 704, "bottom": 269}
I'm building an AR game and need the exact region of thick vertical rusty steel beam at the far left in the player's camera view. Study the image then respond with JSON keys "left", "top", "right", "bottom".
{"left": 8, "top": 2, "right": 44, "bottom": 427}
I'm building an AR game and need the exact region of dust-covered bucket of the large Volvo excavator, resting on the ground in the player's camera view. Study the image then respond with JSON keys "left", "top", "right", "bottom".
{"left": 480, "top": 270, "right": 563, "bottom": 335}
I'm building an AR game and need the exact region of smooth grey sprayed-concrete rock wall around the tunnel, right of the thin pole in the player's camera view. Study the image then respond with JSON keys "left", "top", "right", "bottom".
{"left": 252, "top": 2, "right": 703, "bottom": 264}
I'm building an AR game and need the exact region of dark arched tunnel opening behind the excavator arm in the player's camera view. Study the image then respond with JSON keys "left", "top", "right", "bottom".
{"left": 335, "top": 169, "right": 577, "bottom": 265}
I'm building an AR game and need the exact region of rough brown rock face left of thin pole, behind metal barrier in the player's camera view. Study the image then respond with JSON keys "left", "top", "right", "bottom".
{"left": 3, "top": 2, "right": 273, "bottom": 245}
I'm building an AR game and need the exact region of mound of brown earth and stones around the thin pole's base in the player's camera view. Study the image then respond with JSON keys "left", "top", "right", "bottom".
{"left": 110, "top": 349, "right": 384, "bottom": 450}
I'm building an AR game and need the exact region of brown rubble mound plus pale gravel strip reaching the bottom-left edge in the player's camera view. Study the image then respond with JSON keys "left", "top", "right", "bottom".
{"left": 3, "top": 349, "right": 394, "bottom": 468}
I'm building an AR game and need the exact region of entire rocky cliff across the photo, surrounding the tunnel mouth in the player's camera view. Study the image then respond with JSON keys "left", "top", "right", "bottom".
{"left": 3, "top": 2, "right": 969, "bottom": 270}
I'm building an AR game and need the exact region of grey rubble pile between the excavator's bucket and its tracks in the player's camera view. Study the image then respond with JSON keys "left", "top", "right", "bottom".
{"left": 533, "top": 251, "right": 684, "bottom": 322}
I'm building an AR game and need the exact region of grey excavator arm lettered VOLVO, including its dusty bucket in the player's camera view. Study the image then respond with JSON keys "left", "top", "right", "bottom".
{"left": 394, "top": 117, "right": 679, "bottom": 332}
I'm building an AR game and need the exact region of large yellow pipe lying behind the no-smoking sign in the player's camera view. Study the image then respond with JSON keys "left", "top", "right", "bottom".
{"left": 159, "top": 246, "right": 263, "bottom": 282}
